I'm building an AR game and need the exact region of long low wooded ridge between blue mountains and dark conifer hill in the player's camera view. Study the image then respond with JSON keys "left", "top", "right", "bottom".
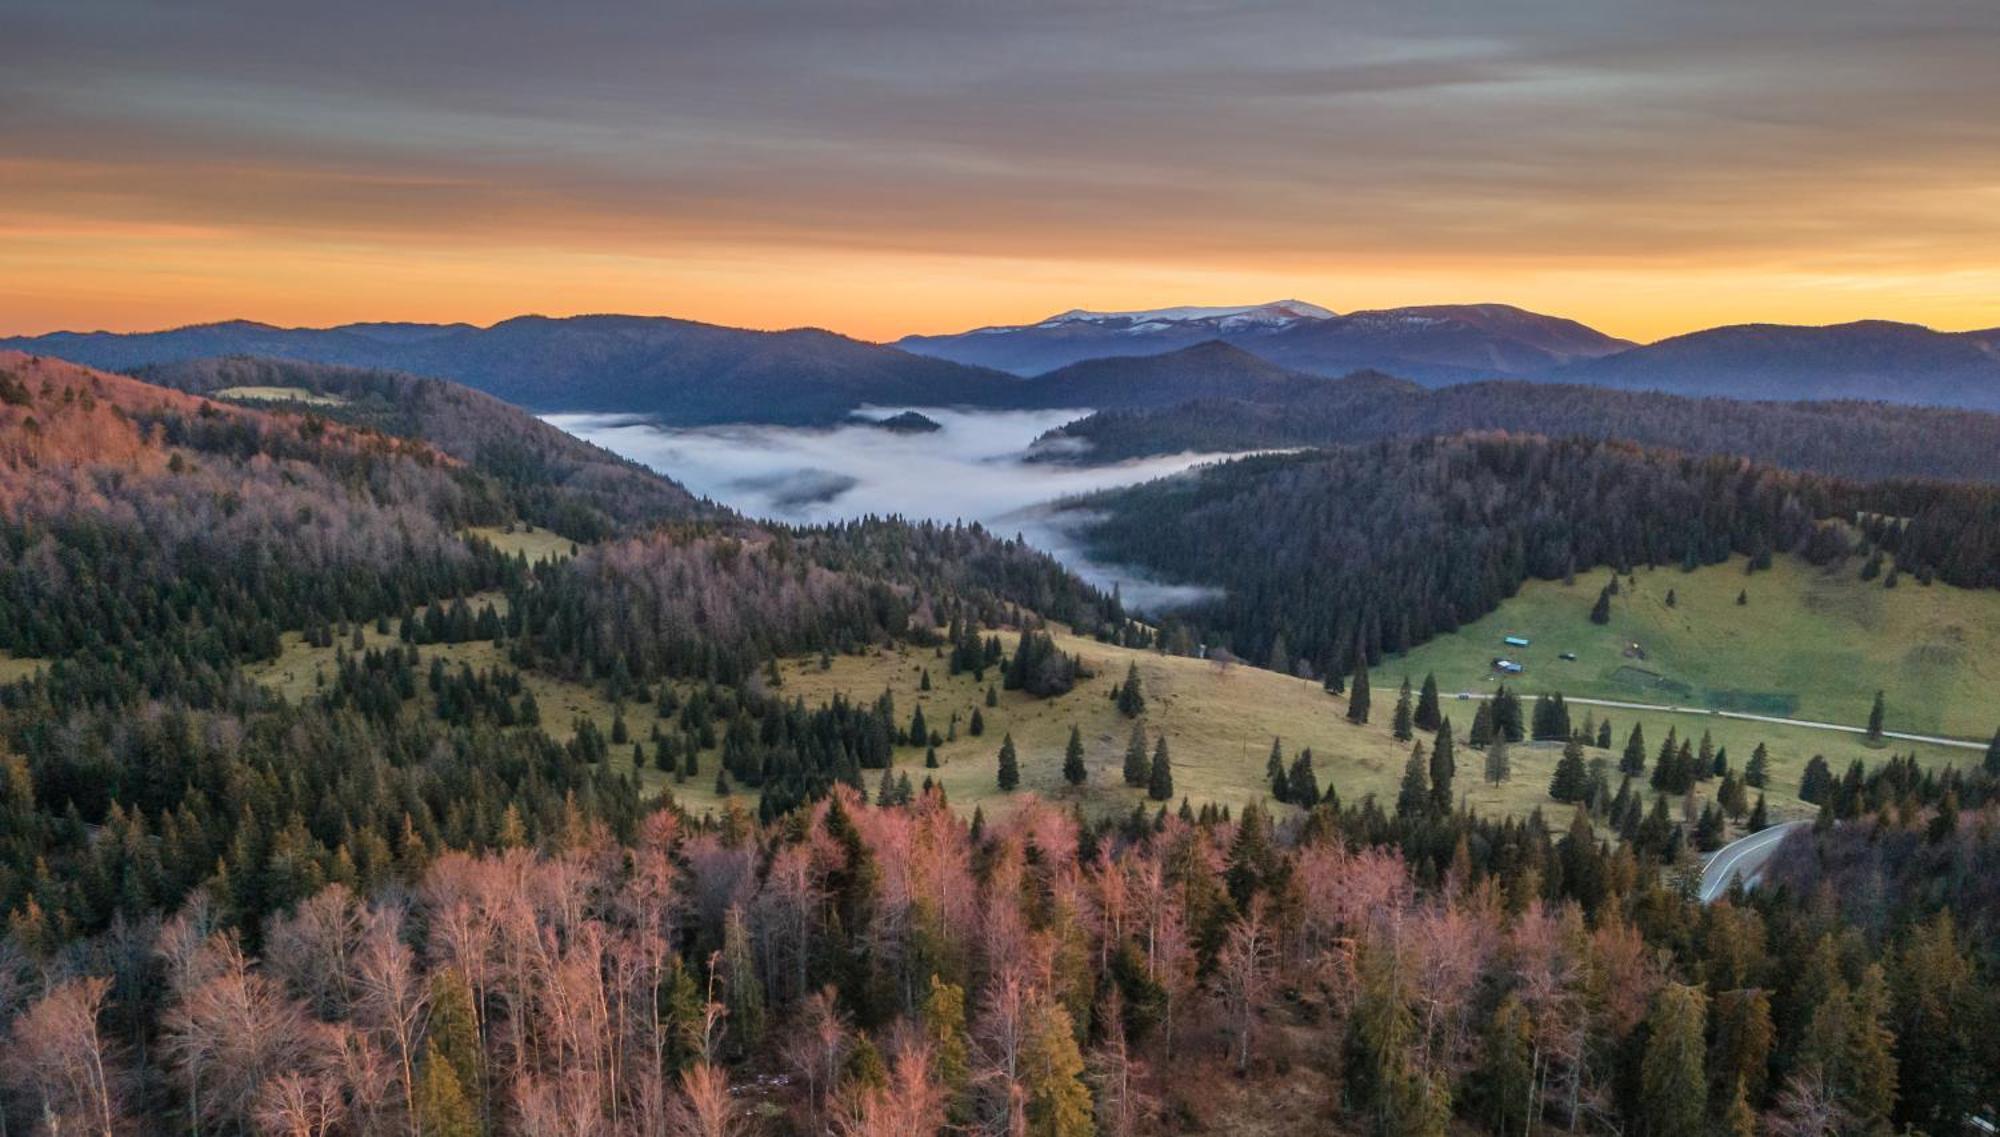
{"left": 1044, "top": 372, "right": 2000, "bottom": 482}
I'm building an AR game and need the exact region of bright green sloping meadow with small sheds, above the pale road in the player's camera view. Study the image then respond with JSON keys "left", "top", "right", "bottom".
{"left": 1374, "top": 556, "right": 2000, "bottom": 740}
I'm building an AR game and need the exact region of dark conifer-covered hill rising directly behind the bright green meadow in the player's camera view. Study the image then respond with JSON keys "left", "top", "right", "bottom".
{"left": 1076, "top": 434, "right": 2000, "bottom": 675}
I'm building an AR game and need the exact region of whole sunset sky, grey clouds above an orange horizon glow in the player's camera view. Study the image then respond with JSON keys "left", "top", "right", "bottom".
{"left": 0, "top": 0, "right": 2000, "bottom": 340}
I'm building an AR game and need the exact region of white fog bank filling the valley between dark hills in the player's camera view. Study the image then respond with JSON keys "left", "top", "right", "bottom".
{"left": 548, "top": 406, "right": 1228, "bottom": 611}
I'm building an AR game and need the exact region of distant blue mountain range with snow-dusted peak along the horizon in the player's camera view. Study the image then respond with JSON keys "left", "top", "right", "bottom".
{"left": 11, "top": 300, "right": 2000, "bottom": 424}
